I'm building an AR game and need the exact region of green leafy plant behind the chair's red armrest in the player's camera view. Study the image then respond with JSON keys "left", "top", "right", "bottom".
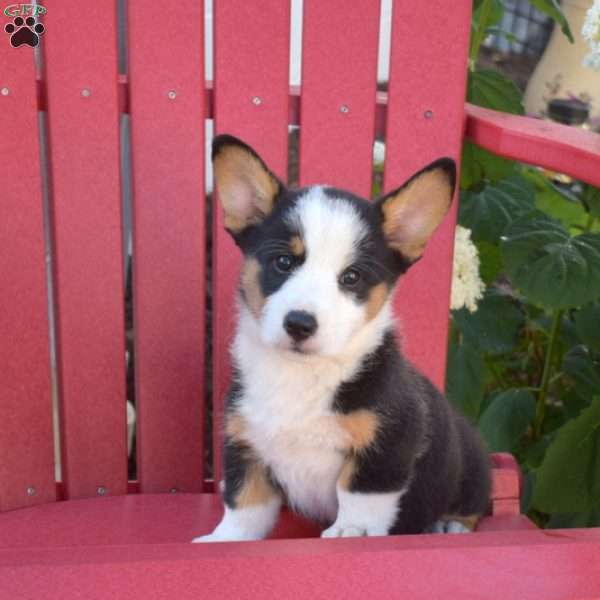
{"left": 446, "top": 0, "right": 600, "bottom": 527}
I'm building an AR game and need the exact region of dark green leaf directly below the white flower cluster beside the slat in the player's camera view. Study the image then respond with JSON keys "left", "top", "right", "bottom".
{"left": 452, "top": 288, "right": 525, "bottom": 354}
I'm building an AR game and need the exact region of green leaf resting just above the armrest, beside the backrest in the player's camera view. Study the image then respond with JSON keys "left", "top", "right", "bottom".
{"left": 467, "top": 69, "right": 525, "bottom": 115}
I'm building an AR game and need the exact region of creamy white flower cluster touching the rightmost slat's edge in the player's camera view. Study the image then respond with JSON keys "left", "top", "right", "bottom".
{"left": 450, "top": 225, "right": 485, "bottom": 312}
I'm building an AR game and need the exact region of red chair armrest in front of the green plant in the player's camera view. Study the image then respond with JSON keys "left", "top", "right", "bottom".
{"left": 466, "top": 104, "right": 600, "bottom": 186}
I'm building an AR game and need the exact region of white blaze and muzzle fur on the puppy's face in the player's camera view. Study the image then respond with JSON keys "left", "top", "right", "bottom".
{"left": 260, "top": 187, "right": 367, "bottom": 356}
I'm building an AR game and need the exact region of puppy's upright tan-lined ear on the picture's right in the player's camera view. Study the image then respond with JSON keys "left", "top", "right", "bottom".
{"left": 376, "top": 158, "right": 456, "bottom": 262}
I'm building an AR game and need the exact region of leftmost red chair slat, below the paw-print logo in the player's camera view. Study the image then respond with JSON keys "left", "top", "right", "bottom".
{"left": 0, "top": 45, "right": 56, "bottom": 511}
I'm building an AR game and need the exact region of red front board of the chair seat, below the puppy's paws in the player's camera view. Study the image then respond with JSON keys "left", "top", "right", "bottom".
{"left": 0, "top": 530, "right": 600, "bottom": 600}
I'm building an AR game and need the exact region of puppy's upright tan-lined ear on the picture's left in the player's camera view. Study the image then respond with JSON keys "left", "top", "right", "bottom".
{"left": 212, "top": 135, "right": 283, "bottom": 235}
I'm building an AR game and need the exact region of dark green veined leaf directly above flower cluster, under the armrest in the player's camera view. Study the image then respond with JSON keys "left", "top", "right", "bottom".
{"left": 458, "top": 175, "right": 535, "bottom": 244}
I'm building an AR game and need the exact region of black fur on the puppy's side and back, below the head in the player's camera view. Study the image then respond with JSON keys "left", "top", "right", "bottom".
{"left": 333, "top": 332, "right": 491, "bottom": 533}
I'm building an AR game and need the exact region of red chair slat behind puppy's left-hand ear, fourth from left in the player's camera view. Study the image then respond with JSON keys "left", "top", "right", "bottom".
{"left": 213, "top": 0, "right": 290, "bottom": 480}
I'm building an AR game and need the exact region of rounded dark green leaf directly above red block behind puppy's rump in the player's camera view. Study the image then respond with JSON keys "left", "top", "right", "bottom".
{"left": 479, "top": 389, "right": 535, "bottom": 452}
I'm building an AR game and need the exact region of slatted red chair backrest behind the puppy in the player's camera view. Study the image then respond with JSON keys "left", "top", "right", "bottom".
{"left": 0, "top": 0, "right": 471, "bottom": 510}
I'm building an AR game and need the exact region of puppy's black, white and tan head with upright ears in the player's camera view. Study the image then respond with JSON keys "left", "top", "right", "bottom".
{"left": 213, "top": 135, "right": 456, "bottom": 356}
